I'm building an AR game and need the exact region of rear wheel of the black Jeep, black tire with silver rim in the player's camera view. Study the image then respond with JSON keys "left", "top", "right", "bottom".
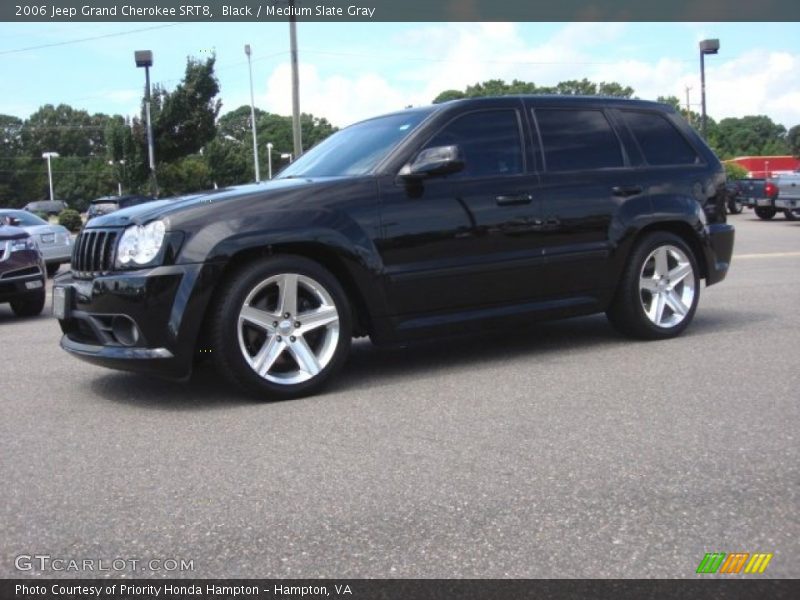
{"left": 606, "top": 231, "right": 700, "bottom": 340}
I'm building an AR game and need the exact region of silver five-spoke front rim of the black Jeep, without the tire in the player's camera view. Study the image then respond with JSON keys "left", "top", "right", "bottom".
{"left": 237, "top": 273, "right": 339, "bottom": 385}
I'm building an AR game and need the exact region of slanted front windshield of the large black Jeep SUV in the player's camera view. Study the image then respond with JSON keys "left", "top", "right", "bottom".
{"left": 278, "top": 110, "right": 430, "bottom": 179}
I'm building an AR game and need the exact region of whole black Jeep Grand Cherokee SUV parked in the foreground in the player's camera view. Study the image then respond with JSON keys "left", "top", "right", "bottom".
{"left": 54, "top": 96, "right": 734, "bottom": 398}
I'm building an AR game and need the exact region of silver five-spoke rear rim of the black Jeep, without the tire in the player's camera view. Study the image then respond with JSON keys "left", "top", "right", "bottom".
{"left": 639, "top": 244, "right": 696, "bottom": 329}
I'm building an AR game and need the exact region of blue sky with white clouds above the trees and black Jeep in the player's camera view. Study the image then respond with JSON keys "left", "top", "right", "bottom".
{"left": 0, "top": 22, "right": 800, "bottom": 129}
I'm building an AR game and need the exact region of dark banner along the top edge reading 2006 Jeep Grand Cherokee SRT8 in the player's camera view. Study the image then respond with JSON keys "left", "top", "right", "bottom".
{"left": 0, "top": 0, "right": 800, "bottom": 22}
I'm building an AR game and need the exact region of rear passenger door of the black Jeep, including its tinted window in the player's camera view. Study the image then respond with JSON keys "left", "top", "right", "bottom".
{"left": 533, "top": 103, "right": 643, "bottom": 302}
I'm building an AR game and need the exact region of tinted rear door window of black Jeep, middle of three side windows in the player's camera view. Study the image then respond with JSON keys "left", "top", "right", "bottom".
{"left": 535, "top": 108, "right": 625, "bottom": 171}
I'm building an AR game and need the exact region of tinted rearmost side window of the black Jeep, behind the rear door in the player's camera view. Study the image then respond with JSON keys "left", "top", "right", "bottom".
{"left": 621, "top": 110, "right": 700, "bottom": 166}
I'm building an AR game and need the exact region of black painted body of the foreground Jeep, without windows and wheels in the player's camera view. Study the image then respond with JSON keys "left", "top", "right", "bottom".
{"left": 56, "top": 97, "right": 733, "bottom": 378}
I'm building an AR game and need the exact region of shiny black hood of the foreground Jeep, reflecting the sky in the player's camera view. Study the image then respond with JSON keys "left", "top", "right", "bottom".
{"left": 86, "top": 177, "right": 351, "bottom": 228}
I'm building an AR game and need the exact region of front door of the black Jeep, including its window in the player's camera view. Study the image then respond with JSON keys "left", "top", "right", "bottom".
{"left": 379, "top": 103, "right": 542, "bottom": 320}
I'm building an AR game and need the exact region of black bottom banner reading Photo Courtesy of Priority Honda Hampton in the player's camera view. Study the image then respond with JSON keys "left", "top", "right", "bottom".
{"left": 0, "top": 578, "right": 800, "bottom": 600}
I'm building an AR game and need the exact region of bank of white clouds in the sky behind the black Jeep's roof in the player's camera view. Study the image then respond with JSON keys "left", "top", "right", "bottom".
{"left": 238, "top": 23, "right": 800, "bottom": 128}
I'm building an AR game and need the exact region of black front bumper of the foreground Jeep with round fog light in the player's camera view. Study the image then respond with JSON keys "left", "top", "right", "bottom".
{"left": 53, "top": 264, "right": 211, "bottom": 379}
